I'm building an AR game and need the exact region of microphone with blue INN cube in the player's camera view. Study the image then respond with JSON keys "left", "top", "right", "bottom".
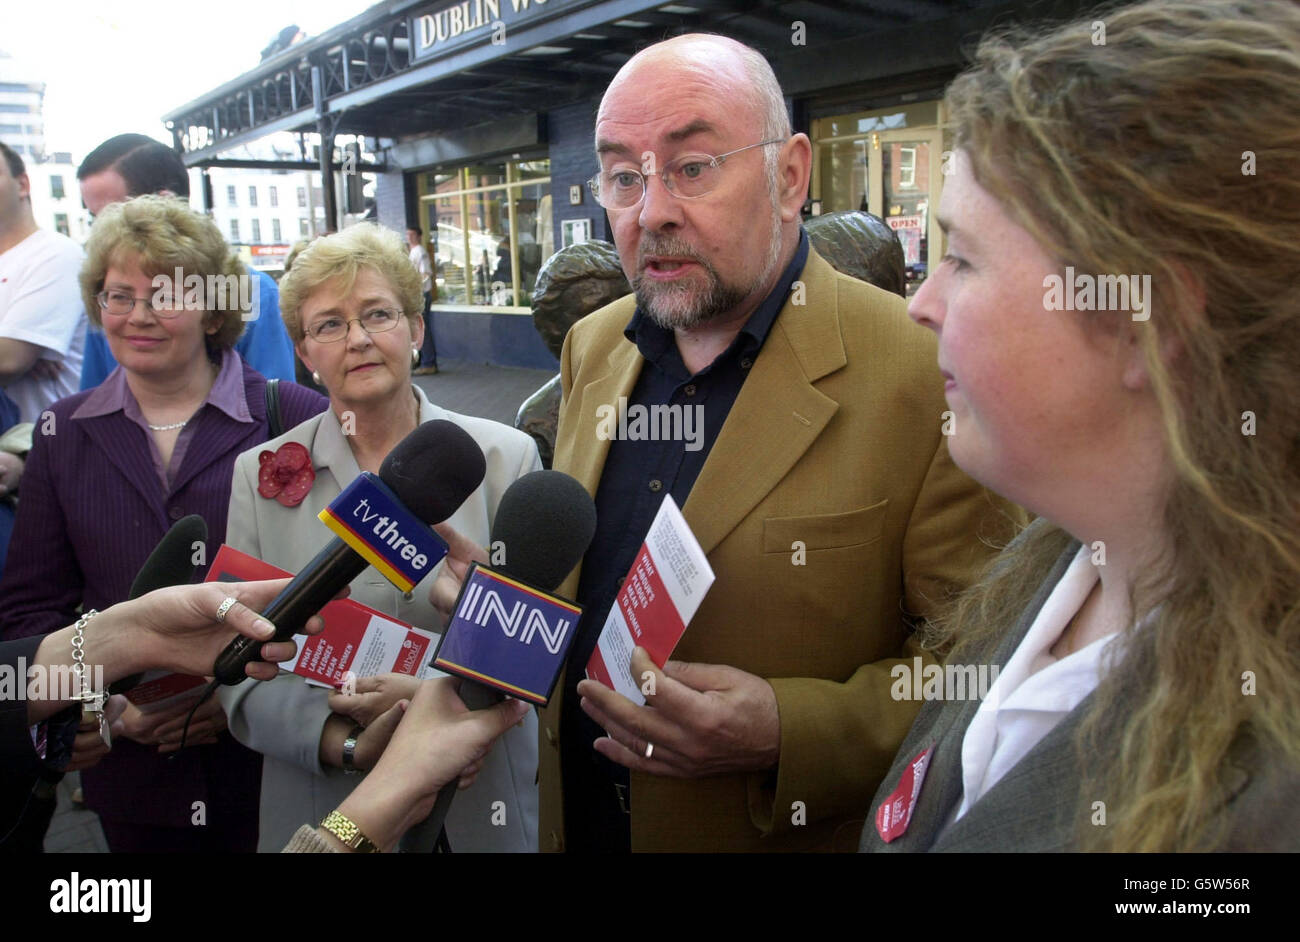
{"left": 402, "top": 470, "right": 595, "bottom": 854}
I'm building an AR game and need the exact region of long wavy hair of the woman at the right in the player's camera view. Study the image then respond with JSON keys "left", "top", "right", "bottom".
{"left": 931, "top": 0, "right": 1300, "bottom": 851}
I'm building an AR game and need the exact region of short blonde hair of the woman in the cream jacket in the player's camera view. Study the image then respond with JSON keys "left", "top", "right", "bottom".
{"left": 280, "top": 222, "right": 424, "bottom": 343}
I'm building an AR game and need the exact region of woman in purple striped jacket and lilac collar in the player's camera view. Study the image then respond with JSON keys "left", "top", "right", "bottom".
{"left": 0, "top": 196, "right": 326, "bottom": 852}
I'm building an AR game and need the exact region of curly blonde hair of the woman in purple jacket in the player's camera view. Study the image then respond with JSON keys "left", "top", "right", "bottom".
{"left": 81, "top": 196, "right": 245, "bottom": 359}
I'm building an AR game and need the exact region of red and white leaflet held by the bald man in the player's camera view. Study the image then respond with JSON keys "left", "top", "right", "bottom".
{"left": 586, "top": 495, "right": 715, "bottom": 703}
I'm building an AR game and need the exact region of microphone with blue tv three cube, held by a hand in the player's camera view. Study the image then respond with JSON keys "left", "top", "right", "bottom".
{"left": 212, "top": 418, "right": 486, "bottom": 685}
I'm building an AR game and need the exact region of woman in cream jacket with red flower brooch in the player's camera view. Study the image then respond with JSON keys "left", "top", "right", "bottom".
{"left": 221, "top": 225, "right": 541, "bottom": 851}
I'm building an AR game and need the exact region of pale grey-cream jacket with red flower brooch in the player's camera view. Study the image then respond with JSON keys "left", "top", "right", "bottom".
{"left": 220, "top": 386, "right": 542, "bottom": 852}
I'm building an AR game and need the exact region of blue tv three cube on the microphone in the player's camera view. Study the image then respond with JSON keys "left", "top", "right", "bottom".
{"left": 320, "top": 472, "right": 447, "bottom": 592}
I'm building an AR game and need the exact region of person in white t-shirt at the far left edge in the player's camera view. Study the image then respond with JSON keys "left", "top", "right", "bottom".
{"left": 0, "top": 144, "right": 86, "bottom": 422}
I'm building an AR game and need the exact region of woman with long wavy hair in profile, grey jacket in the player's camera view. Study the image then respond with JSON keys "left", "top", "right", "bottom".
{"left": 862, "top": 0, "right": 1300, "bottom": 851}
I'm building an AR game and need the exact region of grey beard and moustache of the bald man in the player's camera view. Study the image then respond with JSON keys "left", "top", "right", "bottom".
{"left": 632, "top": 205, "right": 781, "bottom": 330}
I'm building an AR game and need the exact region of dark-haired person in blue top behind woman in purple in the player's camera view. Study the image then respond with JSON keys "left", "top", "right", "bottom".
{"left": 77, "top": 134, "right": 294, "bottom": 390}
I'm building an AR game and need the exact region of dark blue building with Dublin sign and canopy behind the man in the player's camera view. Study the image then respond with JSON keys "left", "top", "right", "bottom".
{"left": 164, "top": 0, "right": 1092, "bottom": 368}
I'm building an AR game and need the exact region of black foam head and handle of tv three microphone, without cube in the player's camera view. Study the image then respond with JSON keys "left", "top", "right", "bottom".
{"left": 212, "top": 418, "right": 486, "bottom": 685}
